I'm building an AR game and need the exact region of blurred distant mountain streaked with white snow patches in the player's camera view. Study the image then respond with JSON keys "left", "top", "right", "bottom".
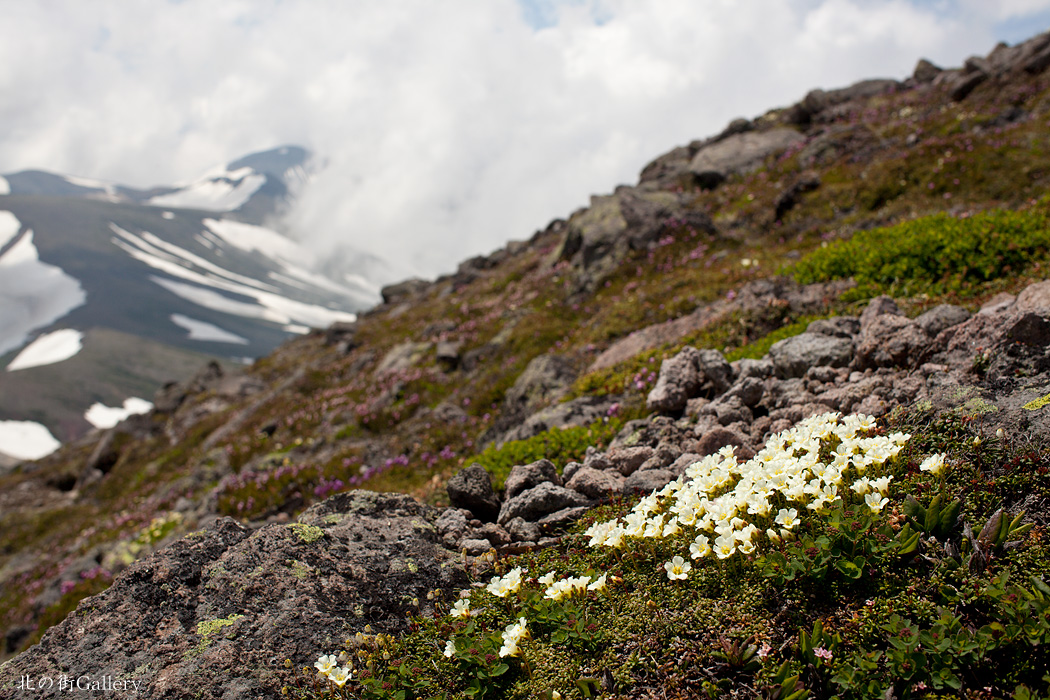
{"left": 0, "top": 146, "right": 379, "bottom": 459}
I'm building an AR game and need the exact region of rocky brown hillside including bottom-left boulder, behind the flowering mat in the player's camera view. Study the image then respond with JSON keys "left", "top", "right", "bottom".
{"left": 0, "top": 30, "right": 1050, "bottom": 697}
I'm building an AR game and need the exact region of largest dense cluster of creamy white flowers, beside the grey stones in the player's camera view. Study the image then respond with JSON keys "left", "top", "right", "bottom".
{"left": 585, "top": 413, "right": 911, "bottom": 580}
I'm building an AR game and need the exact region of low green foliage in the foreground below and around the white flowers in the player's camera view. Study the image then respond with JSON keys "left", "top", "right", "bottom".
{"left": 287, "top": 410, "right": 1050, "bottom": 698}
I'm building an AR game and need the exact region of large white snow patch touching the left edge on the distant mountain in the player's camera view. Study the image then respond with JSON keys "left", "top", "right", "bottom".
{"left": 0, "top": 230, "right": 87, "bottom": 354}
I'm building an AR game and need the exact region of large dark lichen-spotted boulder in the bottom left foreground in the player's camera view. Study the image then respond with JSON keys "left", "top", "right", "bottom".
{"left": 0, "top": 491, "right": 468, "bottom": 699}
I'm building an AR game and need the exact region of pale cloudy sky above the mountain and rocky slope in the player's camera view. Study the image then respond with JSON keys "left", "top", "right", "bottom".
{"left": 0, "top": 0, "right": 1050, "bottom": 276}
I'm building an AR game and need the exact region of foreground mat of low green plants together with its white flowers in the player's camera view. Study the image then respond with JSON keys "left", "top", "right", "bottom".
{"left": 288, "top": 410, "right": 1050, "bottom": 698}
